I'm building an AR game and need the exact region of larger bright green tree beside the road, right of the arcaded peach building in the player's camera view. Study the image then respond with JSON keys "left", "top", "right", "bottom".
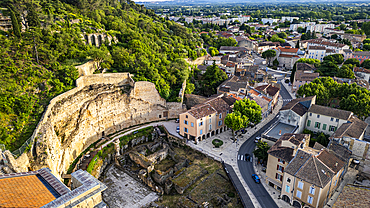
{"left": 233, "top": 99, "right": 262, "bottom": 125}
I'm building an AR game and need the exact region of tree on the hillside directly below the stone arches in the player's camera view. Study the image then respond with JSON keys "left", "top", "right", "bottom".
{"left": 90, "top": 44, "right": 113, "bottom": 70}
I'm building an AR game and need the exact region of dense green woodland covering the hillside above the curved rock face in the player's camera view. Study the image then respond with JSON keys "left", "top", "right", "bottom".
{"left": 0, "top": 0, "right": 205, "bottom": 150}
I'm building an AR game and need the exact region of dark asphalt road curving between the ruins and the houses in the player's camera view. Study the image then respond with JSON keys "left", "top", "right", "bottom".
{"left": 238, "top": 82, "right": 292, "bottom": 208}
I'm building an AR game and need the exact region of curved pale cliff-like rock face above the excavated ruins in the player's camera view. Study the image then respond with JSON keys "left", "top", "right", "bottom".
{"left": 11, "top": 73, "right": 184, "bottom": 177}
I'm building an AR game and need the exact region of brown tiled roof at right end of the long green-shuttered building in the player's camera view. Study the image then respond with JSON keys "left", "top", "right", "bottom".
{"left": 331, "top": 116, "right": 367, "bottom": 139}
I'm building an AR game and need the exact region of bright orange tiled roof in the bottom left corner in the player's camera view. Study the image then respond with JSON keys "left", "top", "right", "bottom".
{"left": 0, "top": 175, "right": 56, "bottom": 208}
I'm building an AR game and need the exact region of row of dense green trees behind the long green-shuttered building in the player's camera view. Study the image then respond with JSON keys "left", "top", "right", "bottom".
{"left": 297, "top": 77, "right": 370, "bottom": 119}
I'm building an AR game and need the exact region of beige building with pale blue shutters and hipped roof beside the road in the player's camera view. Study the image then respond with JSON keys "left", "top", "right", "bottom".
{"left": 281, "top": 147, "right": 347, "bottom": 208}
